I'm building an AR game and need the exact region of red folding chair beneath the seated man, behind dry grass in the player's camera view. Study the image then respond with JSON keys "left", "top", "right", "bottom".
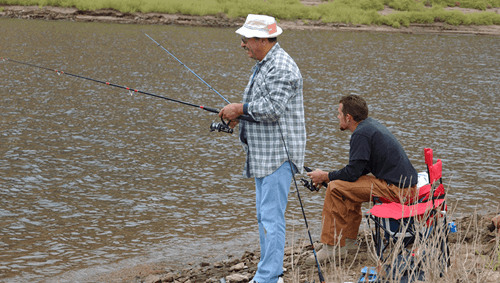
{"left": 366, "top": 148, "right": 449, "bottom": 282}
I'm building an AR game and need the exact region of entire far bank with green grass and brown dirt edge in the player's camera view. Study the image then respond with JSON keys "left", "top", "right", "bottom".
{"left": 0, "top": 0, "right": 500, "bottom": 35}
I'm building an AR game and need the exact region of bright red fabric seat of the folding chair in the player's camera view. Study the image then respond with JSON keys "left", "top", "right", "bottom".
{"left": 369, "top": 199, "right": 444, "bottom": 220}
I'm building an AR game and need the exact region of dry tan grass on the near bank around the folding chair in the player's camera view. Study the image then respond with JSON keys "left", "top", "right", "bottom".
{"left": 285, "top": 195, "right": 500, "bottom": 283}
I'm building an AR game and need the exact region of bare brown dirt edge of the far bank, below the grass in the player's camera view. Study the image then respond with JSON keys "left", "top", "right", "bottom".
{"left": 0, "top": 3, "right": 500, "bottom": 36}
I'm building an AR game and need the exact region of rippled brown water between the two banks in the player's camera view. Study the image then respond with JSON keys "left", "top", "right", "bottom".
{"left": 0, "top": 20, "right": 500, "bottom": 282}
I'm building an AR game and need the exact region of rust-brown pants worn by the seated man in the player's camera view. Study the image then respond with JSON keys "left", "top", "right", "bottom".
{"left": 321, "top": 175, "right": 416, "bottom": 247}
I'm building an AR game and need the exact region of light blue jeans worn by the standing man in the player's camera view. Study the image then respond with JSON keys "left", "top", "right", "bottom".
{"left": 253, "top": 161, "right": 297, "bottom": 283}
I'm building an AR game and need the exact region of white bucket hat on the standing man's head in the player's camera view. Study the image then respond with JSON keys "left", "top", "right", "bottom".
{"left": 236, "top": 14, "right": 283, "bottom": 38}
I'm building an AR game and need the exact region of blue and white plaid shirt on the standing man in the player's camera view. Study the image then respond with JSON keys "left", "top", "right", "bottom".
{"left": 239, "top": 43, "right": 306, "bottom": 178}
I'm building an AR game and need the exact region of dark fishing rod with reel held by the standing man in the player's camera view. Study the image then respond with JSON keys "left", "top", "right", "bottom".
{"left": 0, "top": 57, "right": 258, "bottom": 133}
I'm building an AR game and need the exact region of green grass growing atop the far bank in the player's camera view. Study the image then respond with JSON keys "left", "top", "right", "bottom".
{"left": 0, "top": 0, "right": 500, "bottom": 27}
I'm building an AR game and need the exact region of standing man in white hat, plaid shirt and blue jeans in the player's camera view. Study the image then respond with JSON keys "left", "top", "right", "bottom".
{"left": 219, "top": 14, "right": 306, "bottom": 283}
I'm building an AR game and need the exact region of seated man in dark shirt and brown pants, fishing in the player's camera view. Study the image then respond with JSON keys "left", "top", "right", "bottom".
{"left": 306, "top": 95, "right": 417, "bottom": 264}
